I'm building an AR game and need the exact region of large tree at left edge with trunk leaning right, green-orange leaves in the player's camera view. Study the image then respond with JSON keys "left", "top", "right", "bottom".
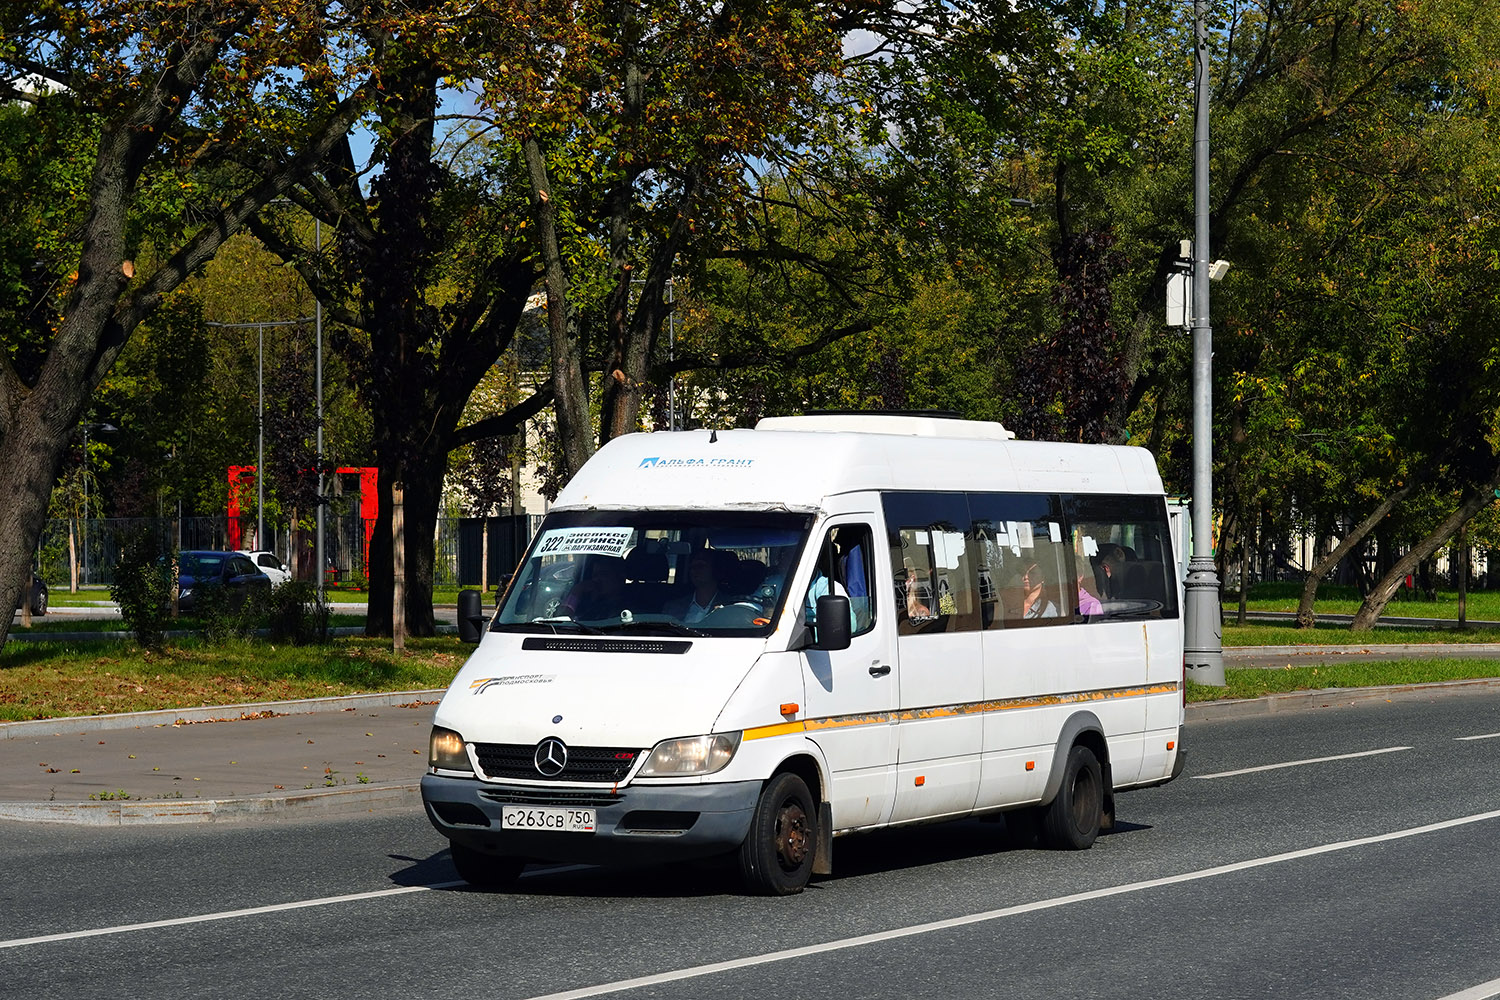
{"left": 0, "top": 0, "right": 420, "bottom": 650}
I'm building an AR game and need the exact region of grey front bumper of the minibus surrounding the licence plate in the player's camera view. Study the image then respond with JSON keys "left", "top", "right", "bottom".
{"left": 422, "top": 774, "right": 761, "bottom": 864}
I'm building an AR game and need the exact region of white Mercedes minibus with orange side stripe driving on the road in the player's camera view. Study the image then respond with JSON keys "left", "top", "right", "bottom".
{"left": 422, "top": 414, "right": 1184, "bottom": 895}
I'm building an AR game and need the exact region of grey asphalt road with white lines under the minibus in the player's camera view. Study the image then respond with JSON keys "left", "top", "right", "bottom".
{"left": 0, "top": 693, "right": 1500, "bottom": 1000}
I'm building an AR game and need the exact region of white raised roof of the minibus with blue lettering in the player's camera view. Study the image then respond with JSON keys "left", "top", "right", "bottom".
{"left": 554, "top": 414, "right": 1163, "bottom": 510}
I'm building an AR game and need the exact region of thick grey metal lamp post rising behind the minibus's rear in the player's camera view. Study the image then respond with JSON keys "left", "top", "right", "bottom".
{"left": 1182, "top": 0, "right": 1224, "bottom": 687}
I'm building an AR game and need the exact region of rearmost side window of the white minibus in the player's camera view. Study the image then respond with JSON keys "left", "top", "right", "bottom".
{"left": 1067, "top": 496, "right": 1178, "bottom": 621}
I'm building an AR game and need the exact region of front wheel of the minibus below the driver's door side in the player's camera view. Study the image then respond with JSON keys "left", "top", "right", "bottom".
{"left": 740, "top": 774, "right": 818, "bottom": 897}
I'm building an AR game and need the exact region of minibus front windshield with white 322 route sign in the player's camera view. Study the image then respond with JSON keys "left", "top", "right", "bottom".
{"left": 491, "top": 510, "right": 813, "bottom": 636}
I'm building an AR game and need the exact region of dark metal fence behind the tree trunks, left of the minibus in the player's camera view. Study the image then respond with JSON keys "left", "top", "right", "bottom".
{"left": 38, "top": 514, "right": 542, "bottom": 589}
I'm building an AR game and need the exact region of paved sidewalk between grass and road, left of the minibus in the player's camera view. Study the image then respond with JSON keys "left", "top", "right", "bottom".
{"left": 0, "top": 691, "right": 443, "bottom": 825}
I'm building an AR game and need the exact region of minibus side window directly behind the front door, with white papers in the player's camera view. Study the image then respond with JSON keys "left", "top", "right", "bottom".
{"left": 881, "top": 493, "right": 980, "bottom": 636}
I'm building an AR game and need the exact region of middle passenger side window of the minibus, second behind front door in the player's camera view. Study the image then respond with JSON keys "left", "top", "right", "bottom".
{"left": 969, "top": 493, "right": 1080, "bottom": 628}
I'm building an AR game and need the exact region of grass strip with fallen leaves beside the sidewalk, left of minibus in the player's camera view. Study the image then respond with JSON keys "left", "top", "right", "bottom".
{"left": 0, "top": 636, "right": 473, "bottom": 721}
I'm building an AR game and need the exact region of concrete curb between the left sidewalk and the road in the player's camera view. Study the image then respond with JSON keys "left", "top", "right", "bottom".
{"left": 0, "top": 781, "right": 422, "bottom": 826}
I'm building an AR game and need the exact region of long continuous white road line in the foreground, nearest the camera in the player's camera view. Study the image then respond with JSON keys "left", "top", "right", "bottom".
{"left": 516, "top": 810, "right": 1500, "bottom": 1000}
